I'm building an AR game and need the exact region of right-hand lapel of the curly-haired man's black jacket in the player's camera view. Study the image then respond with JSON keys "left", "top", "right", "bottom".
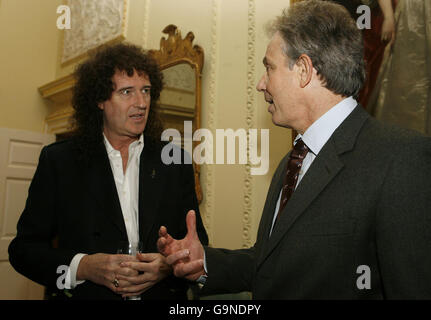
{"left": 139, "top": 141, "right": 166, "bottom": 247}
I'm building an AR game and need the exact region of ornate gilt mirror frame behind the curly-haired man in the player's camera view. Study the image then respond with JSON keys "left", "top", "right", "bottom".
{"left": 150, "top": 24, "right": 204, "bottom": 203}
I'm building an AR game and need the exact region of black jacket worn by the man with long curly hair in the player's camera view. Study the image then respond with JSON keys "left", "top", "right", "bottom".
{"left": 9, "top": 139, "right": 208, "bottom": 299}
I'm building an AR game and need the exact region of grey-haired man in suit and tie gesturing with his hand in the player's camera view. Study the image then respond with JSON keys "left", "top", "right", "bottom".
{"left": 158, "top": 0, "right": 431, "bottom": 299}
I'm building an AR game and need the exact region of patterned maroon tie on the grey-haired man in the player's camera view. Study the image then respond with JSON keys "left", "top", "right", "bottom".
{"left": 276, "top": 139, "right": 308, "bottom": 220}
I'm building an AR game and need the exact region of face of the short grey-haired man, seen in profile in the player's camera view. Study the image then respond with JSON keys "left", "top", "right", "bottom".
{"left": 256, "top": 32, "right": 304, "bottom": 129}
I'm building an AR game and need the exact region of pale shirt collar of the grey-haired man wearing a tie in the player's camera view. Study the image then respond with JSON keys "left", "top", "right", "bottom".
{"left": 295, "top": 97, "right": 358, "bottom": 155}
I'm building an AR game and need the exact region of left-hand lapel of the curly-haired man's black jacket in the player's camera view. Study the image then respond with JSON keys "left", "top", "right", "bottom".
{"left": 86, "top": 142, "right": 127, "bottom": 240}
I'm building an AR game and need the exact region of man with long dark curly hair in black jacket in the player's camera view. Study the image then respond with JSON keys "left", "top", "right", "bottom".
{"left": 9, "top": 43, "right": 208, "bottom": 299}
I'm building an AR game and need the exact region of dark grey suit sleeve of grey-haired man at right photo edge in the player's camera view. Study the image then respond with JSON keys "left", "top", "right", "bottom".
{"left": 376, "top": 137, "right": 431, "bottom": 299}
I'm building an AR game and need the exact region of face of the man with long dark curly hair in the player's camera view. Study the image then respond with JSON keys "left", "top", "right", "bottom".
{"left": 99, "top": 71, "right": 151, "bottom": 141}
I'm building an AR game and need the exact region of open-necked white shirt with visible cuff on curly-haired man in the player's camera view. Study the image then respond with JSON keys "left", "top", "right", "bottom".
{"left": 65, "top": 134, "right": 144, "bottom": 289}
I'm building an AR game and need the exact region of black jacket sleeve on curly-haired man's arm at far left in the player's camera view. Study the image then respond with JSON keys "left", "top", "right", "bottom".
{"left": 9, "top": 147, "right": 77, "bottom": 286}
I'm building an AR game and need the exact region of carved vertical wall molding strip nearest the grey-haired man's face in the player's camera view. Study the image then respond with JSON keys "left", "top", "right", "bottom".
{"left": 242, "top": 0, "right": 256, "bottom": 248}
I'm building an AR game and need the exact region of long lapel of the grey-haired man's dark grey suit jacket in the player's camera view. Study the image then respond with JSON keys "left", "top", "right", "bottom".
{"left": 257, "top": 106, "right": 369, "bottom": 267}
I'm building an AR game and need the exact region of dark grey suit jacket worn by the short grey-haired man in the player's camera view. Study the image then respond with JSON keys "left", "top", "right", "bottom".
{"left": 201, "top": 106, "right": 431, "bottom": 299}
